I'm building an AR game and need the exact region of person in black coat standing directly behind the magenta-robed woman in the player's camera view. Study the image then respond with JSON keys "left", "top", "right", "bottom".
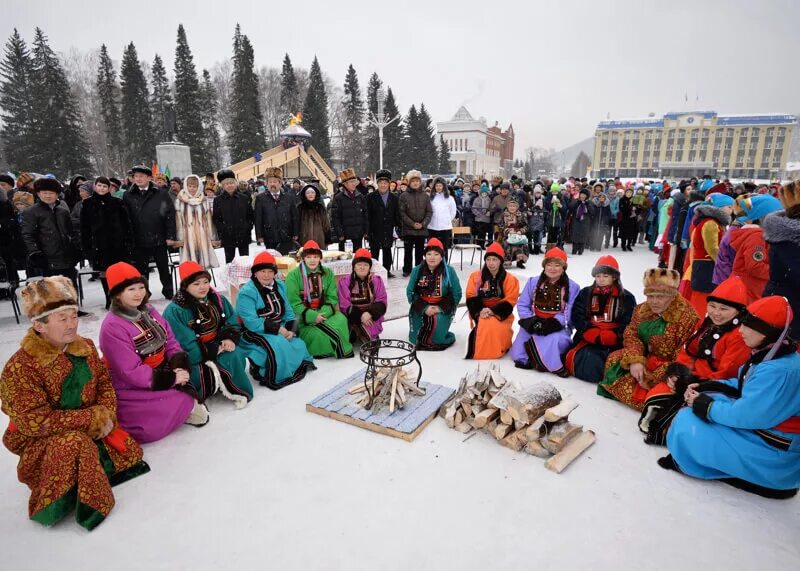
{"left": 80, "top": 176, "right": 133, "bottom": 309}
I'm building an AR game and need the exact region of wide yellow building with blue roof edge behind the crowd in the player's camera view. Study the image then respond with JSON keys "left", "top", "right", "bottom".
{"left": 592, "top": 111, "right": 797, "bottom": 179}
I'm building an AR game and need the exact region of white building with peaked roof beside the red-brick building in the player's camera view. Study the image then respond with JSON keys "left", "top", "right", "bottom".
{"left": 436, "top": 106, "right": 503, "bottom": 178}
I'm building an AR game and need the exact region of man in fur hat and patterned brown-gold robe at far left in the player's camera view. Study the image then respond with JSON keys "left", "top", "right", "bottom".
{"left": 0, "top": 276, "right": 150, "bottom": 530}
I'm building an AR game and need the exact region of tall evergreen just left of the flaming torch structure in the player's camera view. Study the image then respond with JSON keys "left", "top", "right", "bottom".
{"left": 228, "top": 24, "right": 266, "bottom": 162}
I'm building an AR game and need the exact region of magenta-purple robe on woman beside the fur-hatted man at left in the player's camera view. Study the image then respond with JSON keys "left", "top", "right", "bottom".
{"left": 100, "top": 306, "right": 195, "bottom": 442}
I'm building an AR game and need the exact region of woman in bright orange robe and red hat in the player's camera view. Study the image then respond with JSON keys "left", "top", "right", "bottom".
{"left": 466, "top": 242, "right": 519, "bottom": 359}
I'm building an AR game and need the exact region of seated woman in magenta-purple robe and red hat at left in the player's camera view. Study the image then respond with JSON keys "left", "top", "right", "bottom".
{"left": 100, "top": 262, "right": 208, "bottom": 442}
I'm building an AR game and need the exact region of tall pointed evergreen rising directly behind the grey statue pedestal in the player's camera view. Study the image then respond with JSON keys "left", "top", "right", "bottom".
{"left": 175, "top": 24, "right": 212, "bottom": 172}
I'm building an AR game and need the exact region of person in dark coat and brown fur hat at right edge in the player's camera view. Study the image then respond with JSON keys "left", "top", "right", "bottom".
{"left": 762, "top": 181, "right": 800, "bottom": 339}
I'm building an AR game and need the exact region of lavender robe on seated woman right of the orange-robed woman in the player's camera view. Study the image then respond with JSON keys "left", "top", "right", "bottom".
{"left": 511, "top": 276, "right": 581, "bottom": 372}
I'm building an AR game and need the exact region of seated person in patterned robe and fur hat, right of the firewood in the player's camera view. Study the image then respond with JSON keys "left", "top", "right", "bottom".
{"left": 597, "top": 268, "right": 697, "bottom": 410}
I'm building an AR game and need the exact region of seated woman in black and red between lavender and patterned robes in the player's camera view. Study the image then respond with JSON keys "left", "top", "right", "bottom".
{"left": 565, "top": 256, "right": 636, "bottom": 383}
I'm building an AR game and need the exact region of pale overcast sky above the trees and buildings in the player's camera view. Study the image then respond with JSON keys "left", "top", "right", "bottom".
{"left": 0, "top": 0, "right": 800, "bottom": 157}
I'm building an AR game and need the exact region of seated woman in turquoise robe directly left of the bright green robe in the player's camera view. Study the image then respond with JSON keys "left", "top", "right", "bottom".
{"left": 236, "top": 252, "right": 316, "bottom": 390}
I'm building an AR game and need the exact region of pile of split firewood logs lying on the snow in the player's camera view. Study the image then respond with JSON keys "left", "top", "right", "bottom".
{"left": 439, "top": 367, "right": 595, "bottom": 473}
